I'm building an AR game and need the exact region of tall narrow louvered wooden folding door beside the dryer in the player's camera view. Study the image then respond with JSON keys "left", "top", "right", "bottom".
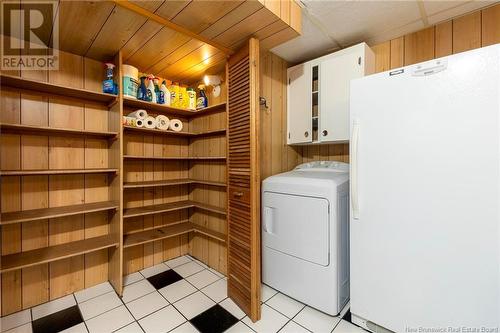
{"left": 227, "top": 38, "right": 261, "bottom": 321}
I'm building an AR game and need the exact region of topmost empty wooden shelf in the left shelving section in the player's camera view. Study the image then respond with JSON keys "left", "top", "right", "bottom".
{"left": 0, "top": 74, "right": 117, "bottom": 104}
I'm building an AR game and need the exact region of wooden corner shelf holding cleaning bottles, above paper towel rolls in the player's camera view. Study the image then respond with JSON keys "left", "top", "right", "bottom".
{"left": 123, "top": 97, "right": 226, "bottom": 118}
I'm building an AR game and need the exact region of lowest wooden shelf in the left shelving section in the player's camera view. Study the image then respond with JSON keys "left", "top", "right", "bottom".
{"left": 1, "top": 235, "right": 119, "bottom": 273}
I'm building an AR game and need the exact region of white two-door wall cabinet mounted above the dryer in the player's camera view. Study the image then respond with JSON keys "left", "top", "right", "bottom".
{"left": 287, "top": 43, "right": 375, "bottom": 144}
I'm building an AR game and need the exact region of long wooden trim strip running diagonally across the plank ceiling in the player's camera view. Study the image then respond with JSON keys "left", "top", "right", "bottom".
{"left": 114, "top": 0, "right": 234, "bottom": 55}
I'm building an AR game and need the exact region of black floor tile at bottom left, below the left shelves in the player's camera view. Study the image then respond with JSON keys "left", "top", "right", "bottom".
{"left": 33, "top": 305, "right": 83, "bottom": 333}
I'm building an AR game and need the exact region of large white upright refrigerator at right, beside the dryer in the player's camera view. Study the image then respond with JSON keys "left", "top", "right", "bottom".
{"left": 350, "top": 44, "right": 500, "bottom": 332}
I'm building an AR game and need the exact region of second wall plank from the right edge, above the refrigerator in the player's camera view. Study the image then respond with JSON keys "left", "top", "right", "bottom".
{"left": 453, "top": 11, "right": 481, "bottom": 53}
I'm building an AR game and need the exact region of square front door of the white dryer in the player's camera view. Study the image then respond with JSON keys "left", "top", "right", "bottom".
{"left": 262, "top": 192, "right": 330, "bottom": 266}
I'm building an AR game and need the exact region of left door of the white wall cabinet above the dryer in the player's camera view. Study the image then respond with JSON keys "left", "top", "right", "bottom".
{"left": 287, "top": 63, "right": 312, "bottom": 144}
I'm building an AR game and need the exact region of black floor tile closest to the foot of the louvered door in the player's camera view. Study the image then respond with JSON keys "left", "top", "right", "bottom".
{"left": 190, "top": 304, "right": 238, "bottom": 333}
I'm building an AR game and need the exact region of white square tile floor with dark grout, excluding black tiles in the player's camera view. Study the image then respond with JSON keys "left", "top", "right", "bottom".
{"left": 0, "top": 256, "right": 366, "bottom": 333}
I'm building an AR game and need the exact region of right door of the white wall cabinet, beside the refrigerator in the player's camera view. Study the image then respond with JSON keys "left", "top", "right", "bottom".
{"left": 319, "top": 53, "right": 364, "bottom": 142}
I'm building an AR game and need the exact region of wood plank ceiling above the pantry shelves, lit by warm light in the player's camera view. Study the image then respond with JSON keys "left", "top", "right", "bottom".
{"left": 52, "top": 0, "right": 300, "bottom": 83}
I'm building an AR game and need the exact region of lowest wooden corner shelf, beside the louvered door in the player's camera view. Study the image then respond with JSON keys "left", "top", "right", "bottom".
{"left": 123, "top": 222, "right": 226, "bottom": 248}
